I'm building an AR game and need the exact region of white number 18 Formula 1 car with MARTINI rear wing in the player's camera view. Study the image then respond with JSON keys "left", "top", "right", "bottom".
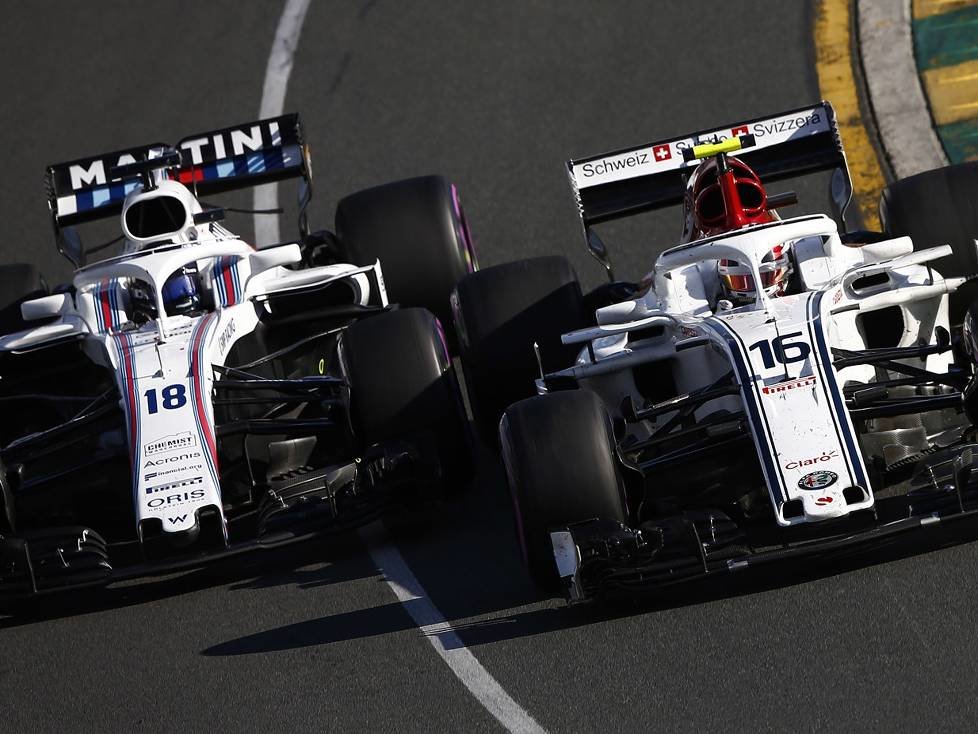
{"left": 0, "top": 114, "right": 475, "bottom": 603}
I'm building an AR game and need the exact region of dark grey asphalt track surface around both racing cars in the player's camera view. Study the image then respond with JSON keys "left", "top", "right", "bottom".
{"left": 0, "top": 0, "right": 978, "bottom": 732}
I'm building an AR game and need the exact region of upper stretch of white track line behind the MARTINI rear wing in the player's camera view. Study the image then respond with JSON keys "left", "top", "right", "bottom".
{"left": 254, "top": 0, "right": 311, "bottom": 247}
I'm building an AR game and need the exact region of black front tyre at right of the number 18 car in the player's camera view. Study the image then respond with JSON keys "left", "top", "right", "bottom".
{"left": 340, "top": 308, "right": 473, "bottom": 494}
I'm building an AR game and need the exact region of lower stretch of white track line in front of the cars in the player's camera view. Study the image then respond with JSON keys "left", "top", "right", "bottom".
{"left": 364, "top": 531, "right": 545, "bottom": 733}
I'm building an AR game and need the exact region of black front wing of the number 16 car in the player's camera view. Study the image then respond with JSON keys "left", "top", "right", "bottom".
{"left": 550, "top": 444, "right": 978, "bottom": 604}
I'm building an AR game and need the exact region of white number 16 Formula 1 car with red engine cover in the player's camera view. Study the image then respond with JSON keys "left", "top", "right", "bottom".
{"left": 453, "top": 102, "right": 978, "bottom": 602}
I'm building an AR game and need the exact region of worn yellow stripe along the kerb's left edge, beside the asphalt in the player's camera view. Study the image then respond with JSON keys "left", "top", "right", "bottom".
{"left": 815, "top": 0, "right": 885, "bottom": 230}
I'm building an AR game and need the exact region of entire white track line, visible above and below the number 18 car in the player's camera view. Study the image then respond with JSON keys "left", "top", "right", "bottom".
{"left": 254, "top": 0, "right": 545, "bottom": 734}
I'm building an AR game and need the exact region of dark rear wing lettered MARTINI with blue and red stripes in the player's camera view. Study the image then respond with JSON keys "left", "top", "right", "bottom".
{"left": 45, "top": 114, "right": 312, "bottom": 268}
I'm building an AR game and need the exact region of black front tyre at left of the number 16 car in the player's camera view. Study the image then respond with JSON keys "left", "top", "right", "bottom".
{"left": 499, "top": 390, "right": 626, "bottom": 590}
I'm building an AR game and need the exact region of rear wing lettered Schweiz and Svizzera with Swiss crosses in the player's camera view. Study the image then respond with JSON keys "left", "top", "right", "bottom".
{"left": 567, "top": 101, "right": 852, "bottom": 238}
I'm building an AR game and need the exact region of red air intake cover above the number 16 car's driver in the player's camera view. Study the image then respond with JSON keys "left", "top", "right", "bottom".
{"left": 686, "top": 156, "right": 775, "bottom": 241}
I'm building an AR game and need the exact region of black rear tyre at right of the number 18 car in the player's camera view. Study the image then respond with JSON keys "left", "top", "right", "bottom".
{"left": 336, "top": 176, "right": 476, "bottom": 351}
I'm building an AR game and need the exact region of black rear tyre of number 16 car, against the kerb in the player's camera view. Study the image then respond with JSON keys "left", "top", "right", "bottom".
{"left": 880, "top": 162, "right": 978, "bottom": 324}
